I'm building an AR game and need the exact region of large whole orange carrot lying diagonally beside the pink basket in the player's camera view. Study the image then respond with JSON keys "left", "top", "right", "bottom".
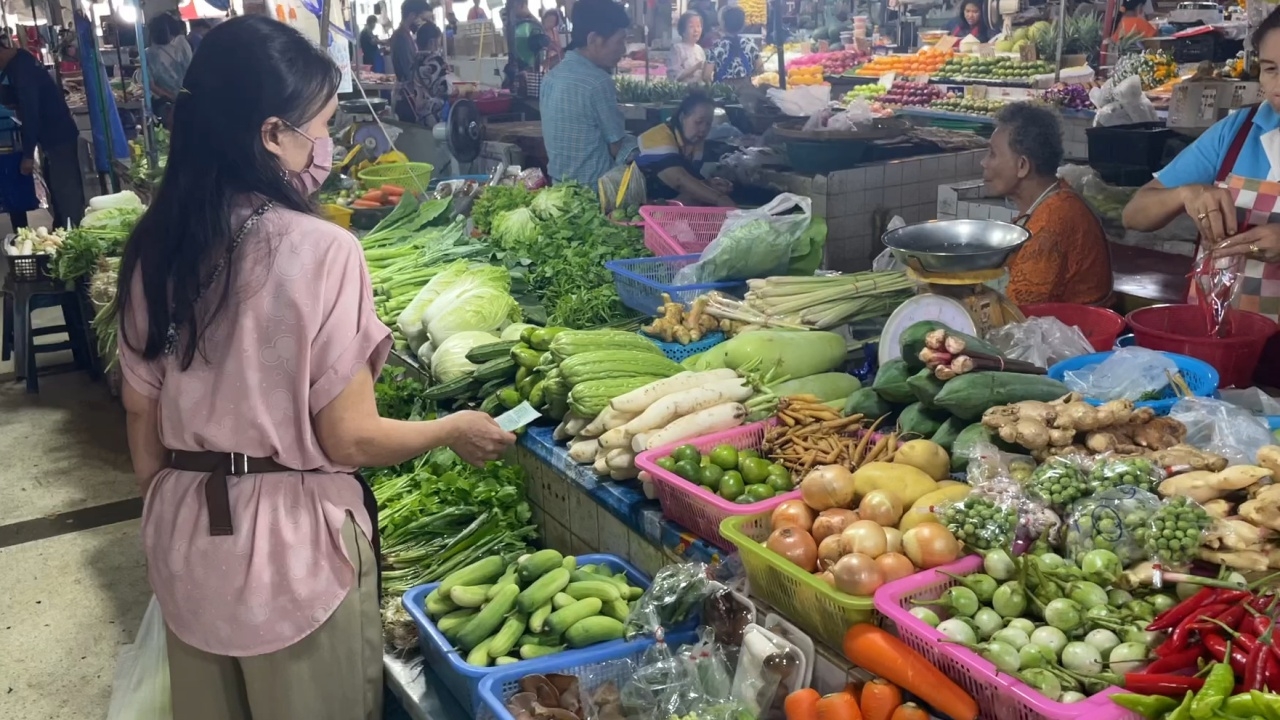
{"left": 842, "top": 623, "right": 978, "bottom": 720}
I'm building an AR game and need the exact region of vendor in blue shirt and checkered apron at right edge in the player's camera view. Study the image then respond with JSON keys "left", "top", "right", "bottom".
{"left": 1124, "top": 10, "right": 1280, "bottom": 319}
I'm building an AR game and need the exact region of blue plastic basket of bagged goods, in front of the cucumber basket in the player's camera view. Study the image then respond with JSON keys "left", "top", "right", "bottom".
{"left": 476, "top": 632, "right": 698, "bottom": 720}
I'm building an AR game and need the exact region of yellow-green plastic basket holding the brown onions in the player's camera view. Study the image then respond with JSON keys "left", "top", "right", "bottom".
{"left": 721, "top": 512, "right": 881, "bottom": 650}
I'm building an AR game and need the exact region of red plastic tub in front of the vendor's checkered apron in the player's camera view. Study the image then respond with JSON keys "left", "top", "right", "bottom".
{"left": 1125, "top": 305, "right": 1277, "bottom": 387}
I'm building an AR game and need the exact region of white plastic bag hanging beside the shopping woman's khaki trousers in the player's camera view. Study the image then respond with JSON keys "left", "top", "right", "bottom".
{"left": 106, "top": 596, "right": 173, "bottom": 720}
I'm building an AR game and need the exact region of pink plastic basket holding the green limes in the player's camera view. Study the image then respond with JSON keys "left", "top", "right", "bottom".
{"left": 636, "top": 420, "right": 800, "bottom": 550}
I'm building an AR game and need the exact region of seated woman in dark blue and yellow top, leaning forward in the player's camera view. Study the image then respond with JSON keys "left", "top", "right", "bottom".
{"left": 636, "top": 92, "right": 733, "bottom": 208}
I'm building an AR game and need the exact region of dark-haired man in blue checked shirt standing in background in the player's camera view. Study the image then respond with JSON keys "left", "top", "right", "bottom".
{"left": 539, "top": 0, "right": 636, "bottom": 184}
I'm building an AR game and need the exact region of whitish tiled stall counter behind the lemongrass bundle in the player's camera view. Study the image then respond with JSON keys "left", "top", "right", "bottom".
{"left": 747, "top": 149, "right": 987, "bottom": 272}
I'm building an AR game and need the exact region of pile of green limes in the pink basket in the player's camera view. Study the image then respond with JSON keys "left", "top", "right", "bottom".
{"left": 657, "top": 443, "right": 795, "bottom": 505}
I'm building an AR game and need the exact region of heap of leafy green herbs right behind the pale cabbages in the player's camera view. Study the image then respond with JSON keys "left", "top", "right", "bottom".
{"left": 483, "top": 183, "right": 649, "bottom": 328}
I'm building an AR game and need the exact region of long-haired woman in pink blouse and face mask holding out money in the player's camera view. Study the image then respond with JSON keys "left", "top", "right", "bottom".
{"left": 119, "top": 15, "right": 515, "bottom": 720}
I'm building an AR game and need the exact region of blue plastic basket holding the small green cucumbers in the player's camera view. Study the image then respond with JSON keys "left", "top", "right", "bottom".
{"left": 401, "top": 555, "right": 653, "bottom": 714}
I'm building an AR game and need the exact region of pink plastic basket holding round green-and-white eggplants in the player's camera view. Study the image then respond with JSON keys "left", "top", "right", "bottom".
{"left": 876, "top": 555, "right": 1142, "bottom": 720}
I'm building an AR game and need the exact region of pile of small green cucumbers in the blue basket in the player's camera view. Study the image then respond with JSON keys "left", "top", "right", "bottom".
{"left": 425, "top": 550, "right": 644, "bottom": 667}
